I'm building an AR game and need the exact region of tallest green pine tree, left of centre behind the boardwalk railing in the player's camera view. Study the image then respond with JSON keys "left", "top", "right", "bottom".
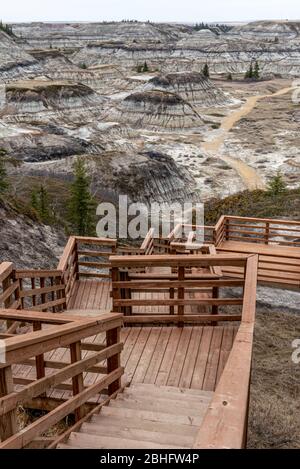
{"left": 69, "top": 158, "right": 96, "bottom": 236}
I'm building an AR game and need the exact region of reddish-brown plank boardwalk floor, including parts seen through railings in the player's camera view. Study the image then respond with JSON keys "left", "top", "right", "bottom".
{"left": 13, "top": 279, "right": 238, "bottom": 401}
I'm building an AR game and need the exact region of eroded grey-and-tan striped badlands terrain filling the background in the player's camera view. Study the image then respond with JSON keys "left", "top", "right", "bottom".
{"left": 0, "top": 21, "right": 300, "bottom": 207}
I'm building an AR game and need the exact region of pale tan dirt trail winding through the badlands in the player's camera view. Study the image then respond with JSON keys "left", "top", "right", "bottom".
{"left": 202, "top": 87, "right": 294, "bottom": 190}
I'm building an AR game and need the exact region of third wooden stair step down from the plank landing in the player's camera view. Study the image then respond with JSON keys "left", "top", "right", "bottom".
{"left": 101, "top": 404, "right": 203, "bottom": 427}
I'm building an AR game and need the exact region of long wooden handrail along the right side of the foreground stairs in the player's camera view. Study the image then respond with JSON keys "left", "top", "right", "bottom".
{"left": 194, "top": 255, "right": 258, "bottom": 449}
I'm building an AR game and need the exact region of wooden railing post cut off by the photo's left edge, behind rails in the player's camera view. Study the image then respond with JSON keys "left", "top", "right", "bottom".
{"left": 0, "top": 366, "right": 17, "bottom": 441}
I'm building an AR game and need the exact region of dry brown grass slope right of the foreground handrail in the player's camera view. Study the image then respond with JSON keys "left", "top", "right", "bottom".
{"left": 248, "top": 308, "right": 300, "bottom": 448}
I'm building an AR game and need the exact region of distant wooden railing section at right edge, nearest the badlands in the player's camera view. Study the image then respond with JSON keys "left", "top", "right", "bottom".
{"left": 214, "top": 216, "right": 300, "bottom": 247}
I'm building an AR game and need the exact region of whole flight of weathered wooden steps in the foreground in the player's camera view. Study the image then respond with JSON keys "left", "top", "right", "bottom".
{"left": 57, "top": 384, "right": 213, "bottom": 449}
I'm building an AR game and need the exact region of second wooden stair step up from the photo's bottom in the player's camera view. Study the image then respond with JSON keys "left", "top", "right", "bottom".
{"left": 80, "top": 420, "right": 194, "bottom": 448}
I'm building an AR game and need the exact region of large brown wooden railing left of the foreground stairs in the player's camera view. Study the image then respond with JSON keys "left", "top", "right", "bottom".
{"left": 0, "top": 309, "right": 123, "bottom": 449}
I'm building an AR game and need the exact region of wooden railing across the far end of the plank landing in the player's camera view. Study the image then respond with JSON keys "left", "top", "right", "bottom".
{"left": 110, "top": 254, "right": 247, "bottom": 326}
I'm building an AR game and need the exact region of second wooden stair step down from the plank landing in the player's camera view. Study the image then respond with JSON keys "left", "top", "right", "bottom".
{"left": 110, "top": 394, "right": 209, "bottom": 416}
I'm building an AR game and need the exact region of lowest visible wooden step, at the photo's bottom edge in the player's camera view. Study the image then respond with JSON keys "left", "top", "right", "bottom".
{"left": 57, "top": 432, "right": 181, "bottom": 449}
